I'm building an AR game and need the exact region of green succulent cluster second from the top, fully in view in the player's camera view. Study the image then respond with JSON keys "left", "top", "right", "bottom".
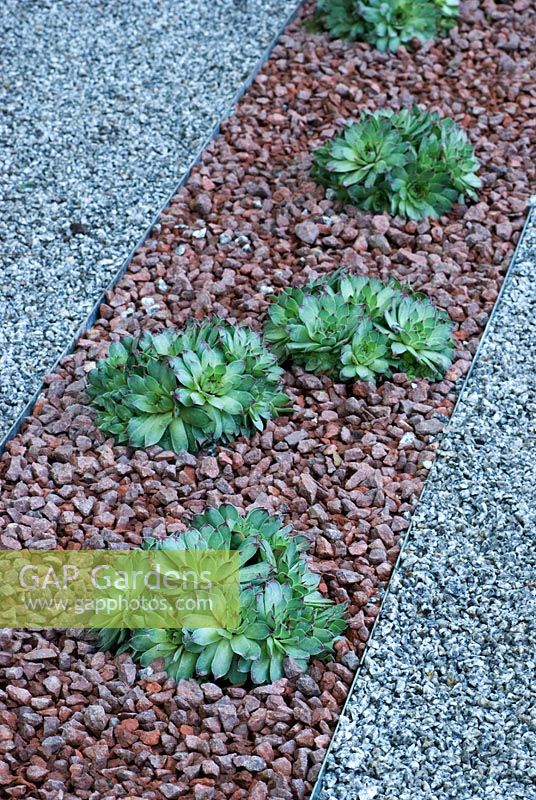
{"left": 312, "top": 108, "right": 481, "bottom": 220}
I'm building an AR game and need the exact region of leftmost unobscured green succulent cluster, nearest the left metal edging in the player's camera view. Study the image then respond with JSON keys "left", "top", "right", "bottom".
{"left": 87, "top": 318, "right": 289, "bottom": 452}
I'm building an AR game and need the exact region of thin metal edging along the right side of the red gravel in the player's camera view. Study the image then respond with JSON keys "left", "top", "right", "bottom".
{"left": 309, "top": 198, "right": 536, "bottom": 800}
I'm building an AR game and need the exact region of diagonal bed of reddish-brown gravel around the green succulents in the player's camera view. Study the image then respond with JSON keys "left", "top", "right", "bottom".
{"left": 0, "top": 0, "right": 536, "bottom": 800}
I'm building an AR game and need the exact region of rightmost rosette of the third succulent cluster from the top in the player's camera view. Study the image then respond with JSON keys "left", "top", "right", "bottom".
{"left": 381, "top": 297, "right": 453, "bottom": 378}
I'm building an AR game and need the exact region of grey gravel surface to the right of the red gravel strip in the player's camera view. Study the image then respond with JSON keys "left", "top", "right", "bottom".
{"left": 319, "top": 210, "right": 536, "bottom": 800}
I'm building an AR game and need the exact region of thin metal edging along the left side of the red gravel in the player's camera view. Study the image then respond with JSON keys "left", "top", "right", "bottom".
{"left": 0, "top": 0, "right": 305, "bottom": 457}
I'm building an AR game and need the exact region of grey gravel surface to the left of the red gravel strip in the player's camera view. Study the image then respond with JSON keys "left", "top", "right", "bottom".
{"left": 0, "top": 0, "right": 297, "bottom": 438}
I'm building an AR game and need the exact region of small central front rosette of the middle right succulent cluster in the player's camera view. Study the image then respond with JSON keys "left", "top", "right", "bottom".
{"left": 340, "top": 319, "right": 392, "bottom": 381}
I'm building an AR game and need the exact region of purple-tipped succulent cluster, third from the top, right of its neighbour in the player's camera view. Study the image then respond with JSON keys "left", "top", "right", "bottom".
{"left": 264, "top": 272, "right": 453, "bottom": 381}
